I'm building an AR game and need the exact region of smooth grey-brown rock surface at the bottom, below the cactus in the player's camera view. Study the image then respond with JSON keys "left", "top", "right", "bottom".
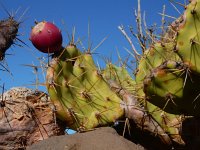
{"left": 27, "top": 127, "right": 145, "bottom": 150}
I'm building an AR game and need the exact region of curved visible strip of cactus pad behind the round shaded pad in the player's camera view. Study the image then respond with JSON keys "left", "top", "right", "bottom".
{"left": 135, "top": 42, "right": 180, "bottom": 101}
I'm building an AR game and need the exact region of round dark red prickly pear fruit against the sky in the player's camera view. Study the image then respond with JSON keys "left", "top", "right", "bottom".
{"left": 30, "top": 21, "right": 62, "bottom": 53}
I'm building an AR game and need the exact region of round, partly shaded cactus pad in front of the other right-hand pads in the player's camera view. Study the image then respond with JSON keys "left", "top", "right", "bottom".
{"left": 144, "top": 61, "right": 200, "bottom": 116}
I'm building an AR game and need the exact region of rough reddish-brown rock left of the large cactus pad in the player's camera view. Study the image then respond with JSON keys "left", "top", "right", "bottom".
{"left": 0, "top": 87, "right": 64, "bottom": 150}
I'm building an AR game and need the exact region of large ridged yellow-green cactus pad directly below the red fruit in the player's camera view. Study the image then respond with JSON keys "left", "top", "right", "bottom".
{"left": 47, "top": 46, "right": 124, "bottom": 131}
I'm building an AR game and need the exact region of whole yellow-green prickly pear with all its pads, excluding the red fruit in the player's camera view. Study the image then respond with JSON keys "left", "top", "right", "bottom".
{"left": 41, "top": 0, "right": 200, "bottom": 148}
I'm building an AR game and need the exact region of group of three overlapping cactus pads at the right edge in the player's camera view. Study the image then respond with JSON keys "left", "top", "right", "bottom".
{"left": 136, "top": 0, "right": 200, "bottom": 116}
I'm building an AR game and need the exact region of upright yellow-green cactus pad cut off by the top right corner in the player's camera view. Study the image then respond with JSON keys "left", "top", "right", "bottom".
{"left": 176, "top": 0, "right": 200, "bottom": 74}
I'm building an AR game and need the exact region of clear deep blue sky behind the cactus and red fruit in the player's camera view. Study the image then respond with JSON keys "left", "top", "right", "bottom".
{"left": 0, "top": 0, "right": 183, "bottom": 90}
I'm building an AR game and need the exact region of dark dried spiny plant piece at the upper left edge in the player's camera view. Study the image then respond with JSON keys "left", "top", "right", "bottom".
{"left": 0, "top": 2, "right": 28, "bottom": 76}
